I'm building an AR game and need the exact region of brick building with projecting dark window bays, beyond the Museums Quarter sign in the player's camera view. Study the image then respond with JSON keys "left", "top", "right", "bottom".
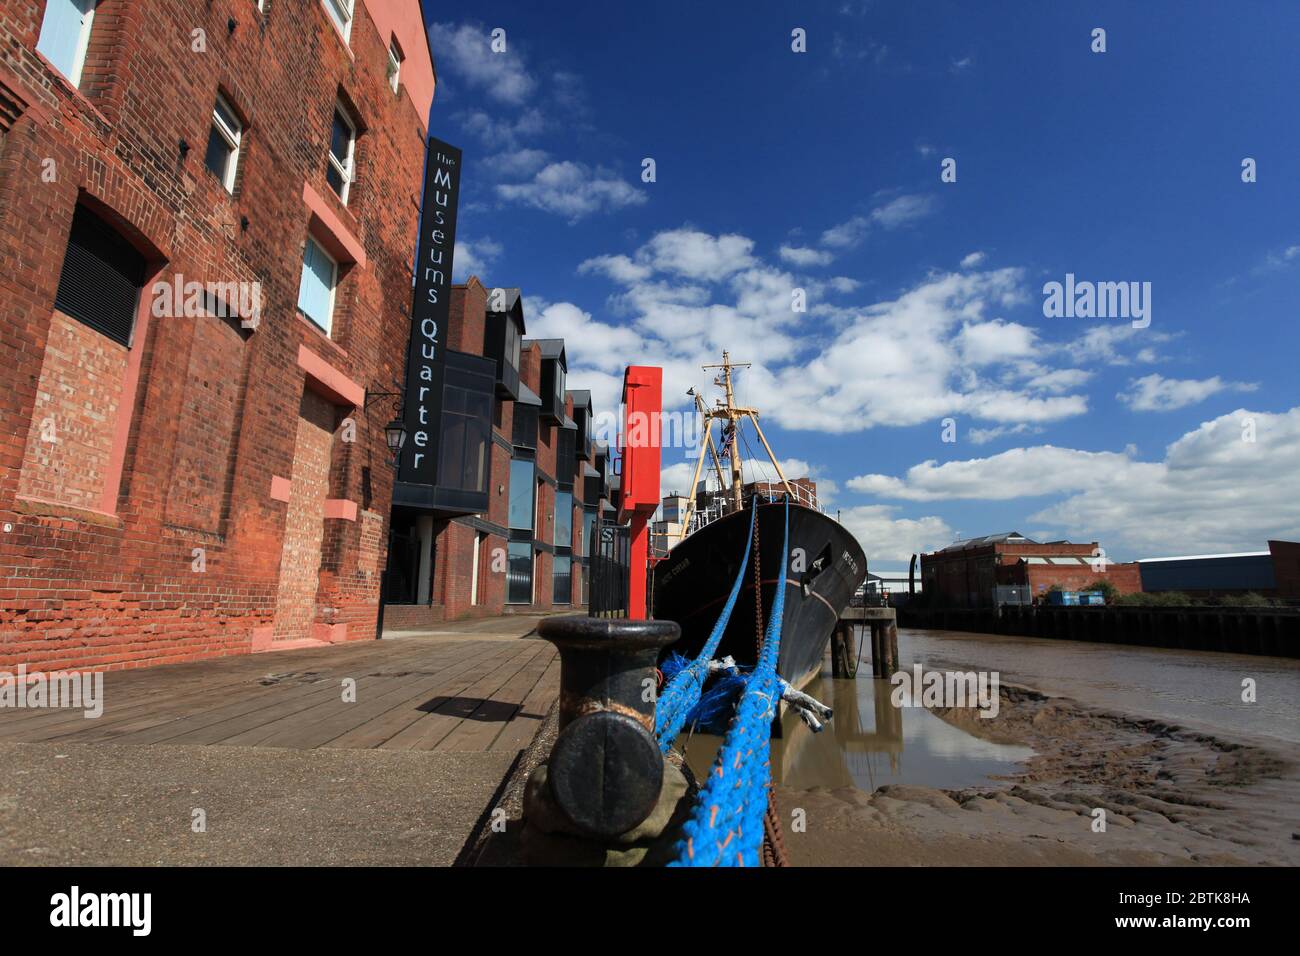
{"left": 384, "top": 277, "right": 614, "bottom": 628}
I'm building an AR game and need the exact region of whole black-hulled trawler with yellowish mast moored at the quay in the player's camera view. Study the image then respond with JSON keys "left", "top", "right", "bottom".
{"left": 653, "top": 351, "right": 867, "bottom": 688}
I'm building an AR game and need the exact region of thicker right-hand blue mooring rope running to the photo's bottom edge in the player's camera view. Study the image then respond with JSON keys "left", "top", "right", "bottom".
{"left": 671, "top": 498, "right": 790, "bottom": 866}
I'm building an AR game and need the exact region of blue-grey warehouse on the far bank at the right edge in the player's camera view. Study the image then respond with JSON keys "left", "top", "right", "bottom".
{"left": 1138, "top": 541, "right": 1300, "bottom": 597}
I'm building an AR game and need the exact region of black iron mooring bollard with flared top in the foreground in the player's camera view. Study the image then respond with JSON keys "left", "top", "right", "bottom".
{"left": 538, "top": 615, "right": 681, "bottom": 838}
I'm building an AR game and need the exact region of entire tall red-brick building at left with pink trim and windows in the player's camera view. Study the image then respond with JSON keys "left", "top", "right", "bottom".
{"left": 0, "top": 0, "right": 436, "bottom": 669}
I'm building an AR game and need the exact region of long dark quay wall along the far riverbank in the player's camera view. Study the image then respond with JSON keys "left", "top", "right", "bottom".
{"left": 898, "top": 605, "right": 1300, "bottom": 658}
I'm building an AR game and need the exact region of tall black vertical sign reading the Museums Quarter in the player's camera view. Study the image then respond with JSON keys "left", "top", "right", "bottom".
{"left": 398, "top": 137, "right": 460, "bottom": 485}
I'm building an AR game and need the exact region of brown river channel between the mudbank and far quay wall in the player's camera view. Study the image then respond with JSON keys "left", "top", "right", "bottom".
{"left": 904, "top": 630, "right": 1300, "bottom": 743}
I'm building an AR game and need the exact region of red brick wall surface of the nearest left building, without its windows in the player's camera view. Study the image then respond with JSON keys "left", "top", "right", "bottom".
{"left": 0, "top": 0, "right": 424, "bottom": 667}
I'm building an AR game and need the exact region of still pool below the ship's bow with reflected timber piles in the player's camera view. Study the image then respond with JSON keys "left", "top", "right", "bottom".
{"left": 679, "top": 669, "right": 1034, "bottom": 792}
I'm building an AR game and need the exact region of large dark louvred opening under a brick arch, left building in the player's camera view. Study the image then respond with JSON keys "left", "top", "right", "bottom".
{"left": 55, "top": 206, "right": 144, "bottom": 346}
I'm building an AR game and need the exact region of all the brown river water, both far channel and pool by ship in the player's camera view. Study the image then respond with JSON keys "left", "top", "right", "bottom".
{"left": 681, "top": 630, "right": 1300, "bottom": 791}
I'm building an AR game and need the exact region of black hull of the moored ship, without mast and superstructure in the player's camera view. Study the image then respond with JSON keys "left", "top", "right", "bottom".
{"left": 654, "top": 502, "right": 867, "bottom": 687}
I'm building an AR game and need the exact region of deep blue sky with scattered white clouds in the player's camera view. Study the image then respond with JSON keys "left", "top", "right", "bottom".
{"left": 425, "top": 0, "right": 1300, "bottom": 568}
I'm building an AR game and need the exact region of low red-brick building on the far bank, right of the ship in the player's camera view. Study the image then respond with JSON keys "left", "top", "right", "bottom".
{"left": 920, "top": 531, "right": 1141, "bottom": 607}
